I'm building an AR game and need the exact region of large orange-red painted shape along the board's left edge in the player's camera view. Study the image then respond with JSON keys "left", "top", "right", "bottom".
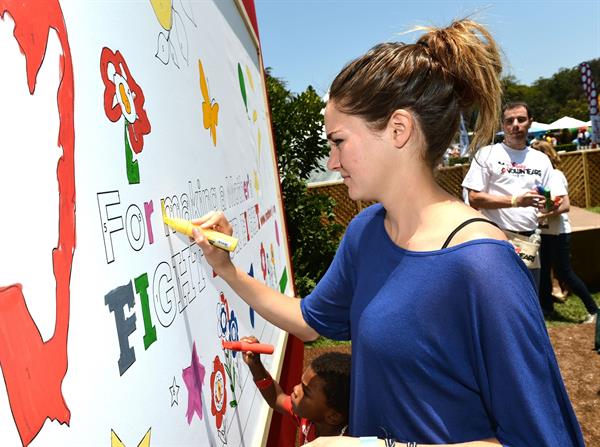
{"left": 0, "top": 0, "right": 75, "bottom": 445}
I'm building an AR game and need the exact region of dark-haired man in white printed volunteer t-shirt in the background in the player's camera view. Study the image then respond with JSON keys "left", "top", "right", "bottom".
{"left": 462, "top": 102, "right": 553, "bottom": 285}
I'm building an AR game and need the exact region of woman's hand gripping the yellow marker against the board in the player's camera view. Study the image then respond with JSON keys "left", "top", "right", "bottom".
{"left": 192, "top": 211, "right": 235, "bottom": 277}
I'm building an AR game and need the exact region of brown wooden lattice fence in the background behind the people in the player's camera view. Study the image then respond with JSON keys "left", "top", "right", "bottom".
{"left": 309, "top": 149, "right": 600, "bottom": 227}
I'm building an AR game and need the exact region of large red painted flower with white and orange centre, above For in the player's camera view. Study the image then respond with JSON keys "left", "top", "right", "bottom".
{"left": 100, "top": 47, "right": 150, "bottom": 154}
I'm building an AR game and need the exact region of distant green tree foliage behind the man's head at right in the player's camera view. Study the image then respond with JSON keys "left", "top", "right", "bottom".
{"left": 502, "top": 58, "right": 600, "bottom": 123}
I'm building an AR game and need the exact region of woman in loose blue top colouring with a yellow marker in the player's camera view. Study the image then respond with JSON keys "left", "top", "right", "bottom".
{"left": 195, "top": 20, "right": 583, "bottom": 446}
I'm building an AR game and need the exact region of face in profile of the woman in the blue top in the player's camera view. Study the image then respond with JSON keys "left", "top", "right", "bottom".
{"left": 325, "top": 101, "right": 386, "bottom": 200}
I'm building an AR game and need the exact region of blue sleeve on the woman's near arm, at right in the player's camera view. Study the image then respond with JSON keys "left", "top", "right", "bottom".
{"left": 466, "top": 248, "right": 584, "bottom": 446}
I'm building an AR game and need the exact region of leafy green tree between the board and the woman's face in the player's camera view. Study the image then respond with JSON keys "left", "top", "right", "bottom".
{"left": 266, "top": 68, "right": 343, "bottom": 296}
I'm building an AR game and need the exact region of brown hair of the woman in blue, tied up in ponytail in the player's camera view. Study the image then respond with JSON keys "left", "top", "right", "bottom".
{"left": 329, "top": 19, "right": 502, "bottom": 167}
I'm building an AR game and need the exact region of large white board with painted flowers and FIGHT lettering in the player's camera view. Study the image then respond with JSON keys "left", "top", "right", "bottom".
{"left": 0, "top": 0, "right": 292, "bottom": 447}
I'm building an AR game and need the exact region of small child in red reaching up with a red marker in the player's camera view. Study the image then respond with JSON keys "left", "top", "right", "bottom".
{"left": 241, "top": 337, "right": 350, "bottom": 445}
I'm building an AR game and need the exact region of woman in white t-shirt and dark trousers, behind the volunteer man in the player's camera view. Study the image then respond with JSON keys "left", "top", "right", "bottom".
{"left": 532, "top": 141, "right": 598, "bottom": 323}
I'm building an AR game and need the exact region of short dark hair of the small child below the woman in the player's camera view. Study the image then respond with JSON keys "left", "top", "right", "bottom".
{"left": 310, "top": 352, "right": 351, "bottom": 419}
